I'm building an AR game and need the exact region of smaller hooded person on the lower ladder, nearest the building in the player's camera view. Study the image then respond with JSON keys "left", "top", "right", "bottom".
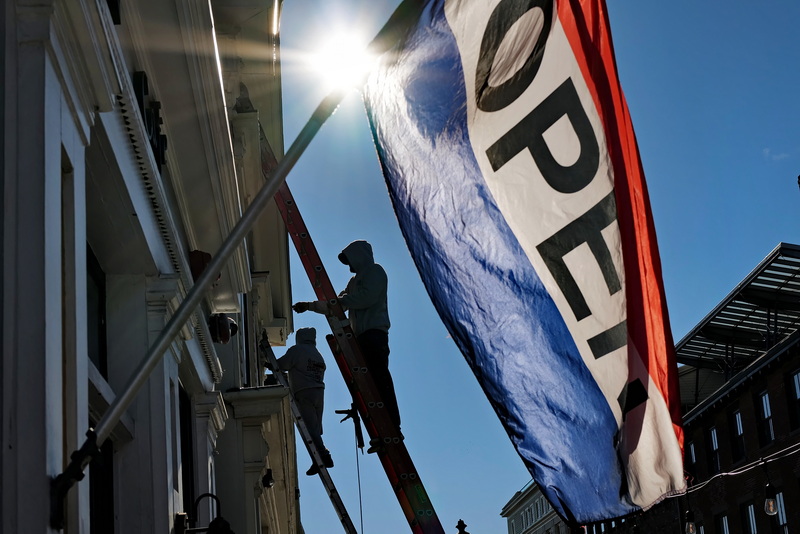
{"left": 278, "top": 328, "right": 333, "bottom": 476}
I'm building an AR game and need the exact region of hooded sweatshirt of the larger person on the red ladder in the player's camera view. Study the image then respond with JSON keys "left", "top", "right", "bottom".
{"left": 339, "top": 240, "right": 390, "bottom": 336}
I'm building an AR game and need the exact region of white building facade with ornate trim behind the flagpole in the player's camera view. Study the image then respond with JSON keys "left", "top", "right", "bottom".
{"left": 0, "top": 0, "right": 301, "bottom": 534}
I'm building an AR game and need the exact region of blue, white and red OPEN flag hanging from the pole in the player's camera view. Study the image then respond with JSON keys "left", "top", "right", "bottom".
{"left": 365, "top": 0, "right": 685, "bottom": 524}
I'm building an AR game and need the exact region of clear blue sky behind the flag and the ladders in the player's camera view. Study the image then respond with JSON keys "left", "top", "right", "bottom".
{"left": 276, "top": 0, "right": 800, "bottom": 534}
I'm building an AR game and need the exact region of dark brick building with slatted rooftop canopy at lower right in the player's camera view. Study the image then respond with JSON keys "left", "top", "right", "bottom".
{"left": 504, "top": 243, "right": 800, "bottom": 534}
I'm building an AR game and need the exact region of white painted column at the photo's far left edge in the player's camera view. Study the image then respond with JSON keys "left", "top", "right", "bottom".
{"left": 0, "top": 2, "right": 64, "bottom": 532}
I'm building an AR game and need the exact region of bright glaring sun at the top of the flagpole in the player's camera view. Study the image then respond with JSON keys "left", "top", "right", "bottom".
{"left": 310, "top": 32, "right": 377, "bottom": 91}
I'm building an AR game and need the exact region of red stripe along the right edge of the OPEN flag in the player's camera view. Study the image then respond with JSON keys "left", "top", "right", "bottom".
{"left": 557, "top": 0, "right": 683, "bottom": 451}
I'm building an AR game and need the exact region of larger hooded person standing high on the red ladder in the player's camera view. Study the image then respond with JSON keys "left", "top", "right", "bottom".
{"left": 293, "top": 240, "right": 402, "bottom": 452}
